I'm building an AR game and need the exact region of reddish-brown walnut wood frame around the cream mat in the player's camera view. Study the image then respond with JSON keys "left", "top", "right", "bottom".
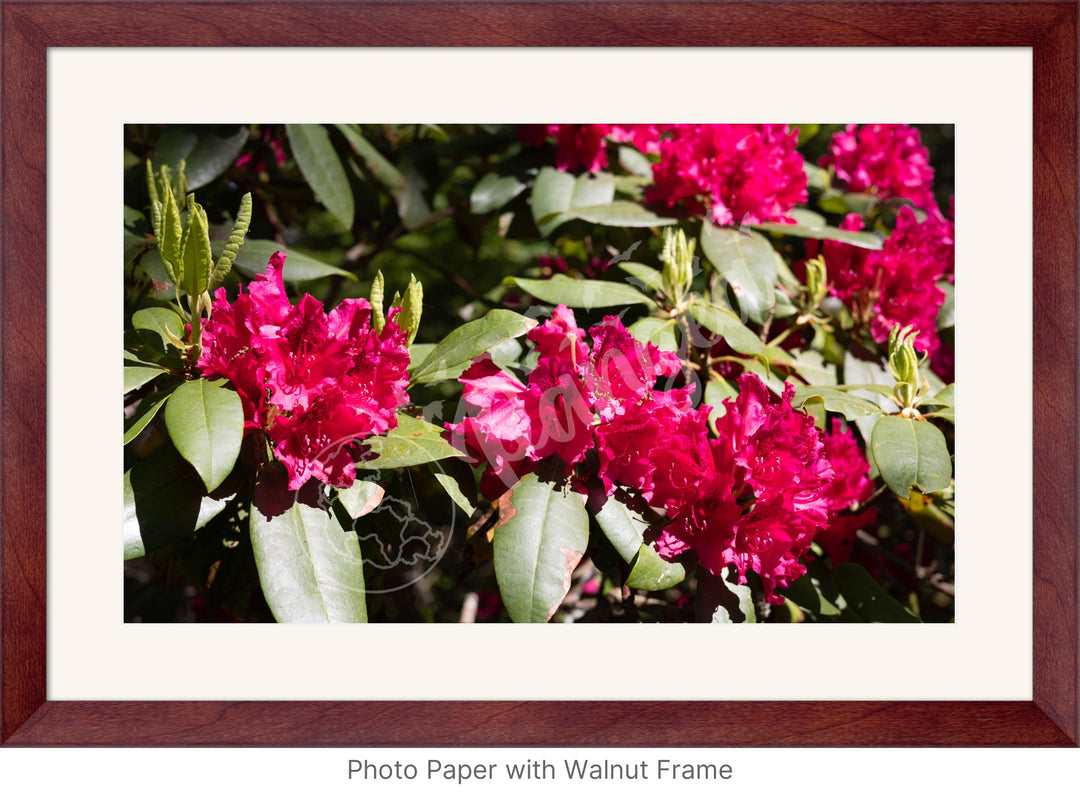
{"left": 0, "top": 2, "right": 1080, "bottom": 746}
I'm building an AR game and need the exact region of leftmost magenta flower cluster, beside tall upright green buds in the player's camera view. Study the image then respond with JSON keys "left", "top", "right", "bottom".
{"left": 199, "top": 252, "right": 409, "bottom": 490}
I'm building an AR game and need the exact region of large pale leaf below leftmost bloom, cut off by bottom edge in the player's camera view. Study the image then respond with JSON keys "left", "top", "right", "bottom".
{"left": 251, "top": 501, "right": 367, "bottom": 624}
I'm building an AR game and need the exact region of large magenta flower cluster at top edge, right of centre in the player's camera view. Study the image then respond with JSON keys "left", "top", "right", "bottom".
{"left": 646, "top": 124, "right": 807, "bottom": 226}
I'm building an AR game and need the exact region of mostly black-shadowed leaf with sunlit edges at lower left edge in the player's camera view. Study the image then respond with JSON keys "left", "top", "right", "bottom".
{"left": 123, "top": 444, "right": 228, "bottom": 560}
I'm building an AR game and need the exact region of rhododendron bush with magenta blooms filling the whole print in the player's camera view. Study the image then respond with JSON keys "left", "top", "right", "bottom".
{"left": 123, "top": 123, "right": 955, "bottom": 623}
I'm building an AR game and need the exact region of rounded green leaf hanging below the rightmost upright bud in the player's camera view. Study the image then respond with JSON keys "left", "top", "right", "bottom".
{"left": 870, "top": 416, "right": 953, "bottom": 499}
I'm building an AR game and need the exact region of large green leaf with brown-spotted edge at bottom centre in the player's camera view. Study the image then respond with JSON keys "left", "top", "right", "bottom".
{"left": 492, "top": 474, "right": 589, "bottom": 623}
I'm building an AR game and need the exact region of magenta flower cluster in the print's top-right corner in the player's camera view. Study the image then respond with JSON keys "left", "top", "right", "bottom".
{"left": 818, "top": 124, "right": 937, "bottom": 212}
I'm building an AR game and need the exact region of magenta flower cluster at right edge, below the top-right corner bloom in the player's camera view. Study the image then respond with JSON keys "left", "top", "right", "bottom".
{"left": 807, "top": 206, "right": 954, "bottom": 355}
